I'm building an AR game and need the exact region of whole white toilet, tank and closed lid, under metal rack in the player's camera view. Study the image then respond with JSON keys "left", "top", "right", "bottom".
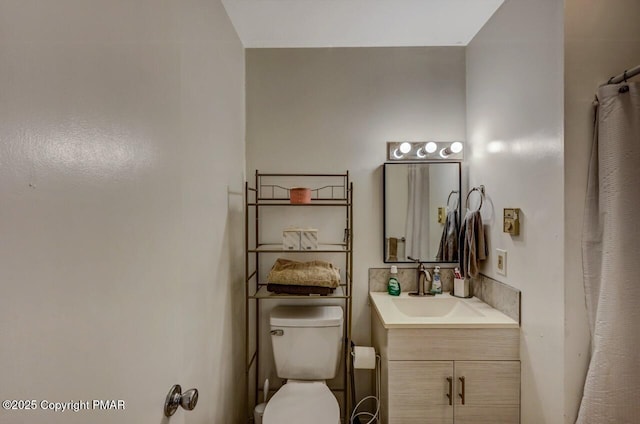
{"left": 262, "top": 306, "right": 344, "bottom": 424}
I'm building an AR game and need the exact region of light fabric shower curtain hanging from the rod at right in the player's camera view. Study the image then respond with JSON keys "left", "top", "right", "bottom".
{"left": 577, "top": 82, "right": 640, "bottom": 424}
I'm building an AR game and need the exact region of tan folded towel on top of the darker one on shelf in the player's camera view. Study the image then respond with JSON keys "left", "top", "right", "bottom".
{"left": 267, "top": 258, "right": 340, "bottom": 288}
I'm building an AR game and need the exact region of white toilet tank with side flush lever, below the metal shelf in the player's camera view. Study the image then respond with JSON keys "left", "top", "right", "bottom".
{"left": 269, "top": 306, "right": 344, "bottom": 380}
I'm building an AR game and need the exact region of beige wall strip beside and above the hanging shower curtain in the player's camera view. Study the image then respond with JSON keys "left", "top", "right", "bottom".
{"left": 564, "top": 0, "right": 640, "bottom": 424}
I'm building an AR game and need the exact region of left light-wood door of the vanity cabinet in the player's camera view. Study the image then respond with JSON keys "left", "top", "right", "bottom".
{"left": 387, "top": 361, "right": 453, "bottom": 424}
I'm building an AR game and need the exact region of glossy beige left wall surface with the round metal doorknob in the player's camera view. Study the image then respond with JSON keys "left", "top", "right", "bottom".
{"left": 0, "top": 0, "right": 244, "bottom": 424}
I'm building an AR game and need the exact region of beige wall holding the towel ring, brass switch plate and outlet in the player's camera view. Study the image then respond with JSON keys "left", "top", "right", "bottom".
{"left": 467, "top": 0, "right": 564, "bottom": 424}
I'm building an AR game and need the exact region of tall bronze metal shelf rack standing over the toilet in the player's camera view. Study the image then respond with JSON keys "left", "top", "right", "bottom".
{"left": 245, "top": 171, "right": 354, "bottom": 419}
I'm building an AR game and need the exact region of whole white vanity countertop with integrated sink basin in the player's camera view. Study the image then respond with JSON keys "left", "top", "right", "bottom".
{"left": 369, "top": 292, "right": 519, "bottom": 328}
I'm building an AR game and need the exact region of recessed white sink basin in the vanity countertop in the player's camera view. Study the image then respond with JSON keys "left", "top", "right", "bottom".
{"left": 391, "top": 296, "right": 482, "bottom": 317}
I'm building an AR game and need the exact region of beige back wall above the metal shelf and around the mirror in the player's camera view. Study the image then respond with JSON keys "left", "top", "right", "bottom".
{"left": 246, "top": 47, "right": 465, "bottom": 400}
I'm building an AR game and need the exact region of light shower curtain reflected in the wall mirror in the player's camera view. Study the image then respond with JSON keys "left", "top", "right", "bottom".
{"left": 405, "top": 164, "right": 432, "bottom": 261}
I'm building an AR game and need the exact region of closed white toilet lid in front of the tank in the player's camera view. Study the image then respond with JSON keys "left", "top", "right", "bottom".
{"left": 262, "top": 381, "right": 340, "bottom": 424}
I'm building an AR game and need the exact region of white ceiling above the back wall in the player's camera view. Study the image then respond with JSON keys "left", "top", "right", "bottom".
{"left": 222, "top": 0, "right": 504, "bottom": 48}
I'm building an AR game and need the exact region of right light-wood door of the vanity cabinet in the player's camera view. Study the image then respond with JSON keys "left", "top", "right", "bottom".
{"left": 454, "top": 361, "right": 520, "bottom": 424}
